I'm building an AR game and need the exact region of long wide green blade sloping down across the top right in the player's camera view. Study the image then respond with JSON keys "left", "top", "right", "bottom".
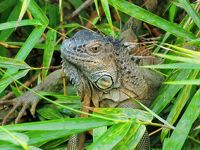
{"left": 108, "top": 0, "right": 196, "bottom": 40}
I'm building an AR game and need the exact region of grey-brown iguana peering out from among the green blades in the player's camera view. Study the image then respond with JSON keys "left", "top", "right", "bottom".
{"left": 1, "top": 30, "right": 163, "bottom": 149}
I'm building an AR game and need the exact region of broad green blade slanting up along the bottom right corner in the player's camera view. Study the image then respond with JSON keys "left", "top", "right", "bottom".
{"left": 163, "top": 89, "right": 200, "bottom": 150}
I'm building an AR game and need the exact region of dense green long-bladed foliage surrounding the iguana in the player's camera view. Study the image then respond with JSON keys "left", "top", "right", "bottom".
{"left": 0, "top": 0, "right": 200, "bottom": 150}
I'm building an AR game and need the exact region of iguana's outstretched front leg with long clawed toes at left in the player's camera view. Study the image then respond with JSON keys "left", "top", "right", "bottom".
{"left": 0, "top": 69, "right": 63, "bottom": 124}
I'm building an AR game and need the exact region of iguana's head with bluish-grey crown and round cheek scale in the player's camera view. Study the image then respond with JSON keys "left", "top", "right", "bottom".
{"left": 61, "top": 30, "right": 117, "bottom": 90}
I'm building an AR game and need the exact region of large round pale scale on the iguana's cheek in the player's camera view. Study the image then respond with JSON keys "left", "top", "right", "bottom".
{"left": 96, "top": 75, "right": 113, "bottom": 90}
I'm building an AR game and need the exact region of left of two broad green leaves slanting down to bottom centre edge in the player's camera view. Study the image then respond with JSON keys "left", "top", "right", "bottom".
{"left": 87, "top": 123, "right": 131, "bottom": 150}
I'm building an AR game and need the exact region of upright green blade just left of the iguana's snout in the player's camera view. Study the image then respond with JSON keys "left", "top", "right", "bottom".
{"left": 42, "top": 30, "right": 56, "bottom": 79}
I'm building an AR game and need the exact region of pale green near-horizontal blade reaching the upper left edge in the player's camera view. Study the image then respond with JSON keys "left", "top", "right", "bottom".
{"left": 0, "top": 19, "right": 42, "bottom": 30}
